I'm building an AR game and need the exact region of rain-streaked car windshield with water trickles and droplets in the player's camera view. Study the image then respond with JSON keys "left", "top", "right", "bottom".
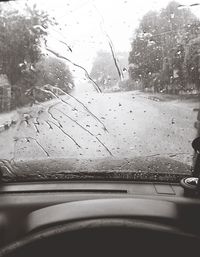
{"left": 0, "top": 0, "right": 200, "bottom": 181}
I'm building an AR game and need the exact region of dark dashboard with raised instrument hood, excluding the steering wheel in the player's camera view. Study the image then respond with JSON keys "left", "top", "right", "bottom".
{"left": 0, "top": 181, "right": 200, "bottom": 256}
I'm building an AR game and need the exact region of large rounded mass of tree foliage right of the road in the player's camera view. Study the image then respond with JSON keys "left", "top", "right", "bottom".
{"left": 129, "top": 1, "right": 200, "bottom": 93}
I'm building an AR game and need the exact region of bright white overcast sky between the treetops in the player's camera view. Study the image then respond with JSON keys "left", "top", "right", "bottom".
{"left": 12, "top": 0, "right": 200, "bottom": 76}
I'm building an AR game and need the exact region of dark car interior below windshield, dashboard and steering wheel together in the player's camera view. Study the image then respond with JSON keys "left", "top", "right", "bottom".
{"left": 0, "top": 170, "right": 200, "bottom": 256}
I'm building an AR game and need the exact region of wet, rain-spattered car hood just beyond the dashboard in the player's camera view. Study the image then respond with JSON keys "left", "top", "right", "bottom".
{"left": 0, "top": 157, "right": 191, "bottom": 182}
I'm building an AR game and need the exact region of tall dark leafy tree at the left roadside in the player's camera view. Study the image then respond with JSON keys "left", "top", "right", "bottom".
{"left": 0, "top": 3, "right": 53, "bottom": 106}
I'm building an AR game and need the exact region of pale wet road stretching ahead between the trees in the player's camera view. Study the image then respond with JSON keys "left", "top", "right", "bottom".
{"left": 0, "top": 91, "right": 198, "bottom": 164}
